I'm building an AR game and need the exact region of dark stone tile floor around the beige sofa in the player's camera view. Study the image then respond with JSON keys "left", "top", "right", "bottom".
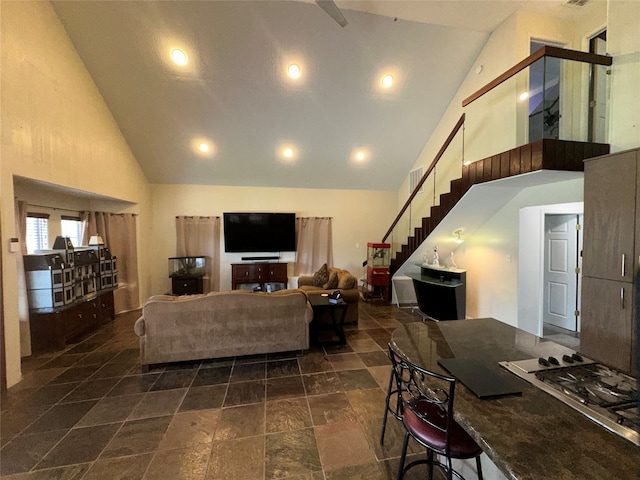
{"left": 0, "top": 302, "right": 450, "bottom": 480}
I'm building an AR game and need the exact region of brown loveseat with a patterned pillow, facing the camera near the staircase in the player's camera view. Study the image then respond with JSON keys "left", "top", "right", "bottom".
{"left": 298, "top": 264, "right": 360, "bottom": 324}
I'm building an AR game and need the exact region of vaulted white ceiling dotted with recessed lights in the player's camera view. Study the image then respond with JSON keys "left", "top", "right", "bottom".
{"left": 53, "top": 0, "right": 576, "bottom": 190}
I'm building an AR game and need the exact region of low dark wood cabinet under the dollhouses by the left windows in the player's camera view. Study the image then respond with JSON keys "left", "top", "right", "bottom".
{"left": 29, "top": 290, "right": 115, "bottom": 353}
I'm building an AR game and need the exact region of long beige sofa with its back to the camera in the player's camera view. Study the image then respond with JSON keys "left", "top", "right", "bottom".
{"left": 134, "top": 289, "right": 313, "bottom": 370}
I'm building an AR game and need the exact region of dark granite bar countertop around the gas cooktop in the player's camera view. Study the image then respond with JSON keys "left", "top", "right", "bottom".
{"left": 392, "top": 318, "right": 640, "bottom": 480}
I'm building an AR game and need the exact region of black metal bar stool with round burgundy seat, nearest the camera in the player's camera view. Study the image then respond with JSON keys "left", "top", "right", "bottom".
{"left": 398, "top": 357, "right": 482, "bottom": 480}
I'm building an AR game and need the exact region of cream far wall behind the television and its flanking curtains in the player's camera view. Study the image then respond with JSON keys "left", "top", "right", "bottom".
{"left": 148, "top": 185, "right": 397, "bottom": 294}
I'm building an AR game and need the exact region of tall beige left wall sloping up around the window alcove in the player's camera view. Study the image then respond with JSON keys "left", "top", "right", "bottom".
{"left": 0, "top": 1, "right": 149, "bottom": 385}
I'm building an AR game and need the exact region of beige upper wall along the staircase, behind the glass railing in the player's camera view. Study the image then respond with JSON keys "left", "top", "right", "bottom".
{"left": 398, "top": 7, "right": 606, "bottom": 204}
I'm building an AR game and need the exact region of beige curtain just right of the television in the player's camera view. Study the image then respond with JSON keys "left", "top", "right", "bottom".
{"left": 295, "top": 217, "right": 333, "bottom": 276}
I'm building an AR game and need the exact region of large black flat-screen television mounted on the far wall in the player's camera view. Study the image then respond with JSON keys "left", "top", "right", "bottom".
{"left": 224, "top": 213, "right": 296, "bottom": 253}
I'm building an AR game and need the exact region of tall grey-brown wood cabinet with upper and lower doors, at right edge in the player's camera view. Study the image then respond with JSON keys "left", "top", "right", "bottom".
{"left": 580, "top": 149, "right": 640, "bottom": 375}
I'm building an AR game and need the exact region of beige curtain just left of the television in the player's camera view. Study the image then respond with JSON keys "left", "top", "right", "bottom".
{"left": 176, "top": 216, "right": 220, "bottom": 293}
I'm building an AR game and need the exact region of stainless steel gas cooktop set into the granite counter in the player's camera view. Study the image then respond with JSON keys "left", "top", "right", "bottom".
{"left": 500, "top": 353, "right": 640, "bottom": 446}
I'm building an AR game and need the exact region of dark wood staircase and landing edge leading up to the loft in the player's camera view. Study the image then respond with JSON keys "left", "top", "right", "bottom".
{"left": 383, "top": 139, "right": 609, "bottom": 278}
